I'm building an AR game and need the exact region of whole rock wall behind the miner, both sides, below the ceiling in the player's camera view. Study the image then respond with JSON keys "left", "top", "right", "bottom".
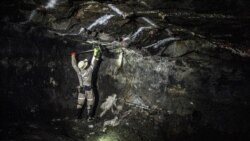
{"left": 1, "top": 21, "right": 250, "bottom": 139}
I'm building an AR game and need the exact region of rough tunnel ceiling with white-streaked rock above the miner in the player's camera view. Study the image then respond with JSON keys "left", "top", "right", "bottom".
{"left": 3, "top": 0, "right": 249, "bottom": 54}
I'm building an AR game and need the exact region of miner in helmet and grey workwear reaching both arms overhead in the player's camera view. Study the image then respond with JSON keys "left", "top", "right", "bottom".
{"left": 71, "top": 47, "right": 101, "bottom": 121}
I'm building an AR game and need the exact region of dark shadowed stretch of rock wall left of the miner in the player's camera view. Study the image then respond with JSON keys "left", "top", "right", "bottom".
{"left": 0, "top": 25, "right": 78, "bottom": 121}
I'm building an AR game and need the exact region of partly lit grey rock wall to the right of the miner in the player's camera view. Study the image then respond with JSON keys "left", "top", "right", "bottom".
{"left": 98, "top": 41, "right": 250, "bottom": 137}
